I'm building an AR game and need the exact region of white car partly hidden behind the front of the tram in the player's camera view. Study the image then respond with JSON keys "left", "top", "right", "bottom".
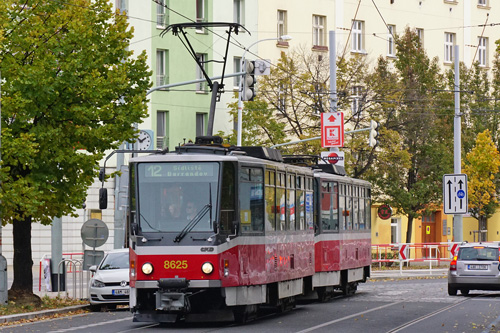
{"left": 89, "top": 249, "right": 130, "bottom": 311}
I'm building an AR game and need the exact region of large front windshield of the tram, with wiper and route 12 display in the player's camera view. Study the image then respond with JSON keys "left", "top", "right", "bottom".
{"left": 137, "top": 162, "right": 220, "bottom": 232}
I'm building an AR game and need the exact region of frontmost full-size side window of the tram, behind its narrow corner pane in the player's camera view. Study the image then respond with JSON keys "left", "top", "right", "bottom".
{"left": 239, "top": 168, "right": 264, "bottom": 232}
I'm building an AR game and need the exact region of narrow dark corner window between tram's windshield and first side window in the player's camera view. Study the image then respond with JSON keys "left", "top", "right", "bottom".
{"left": 220, "top": 162, "right": 236, "bottom": 233}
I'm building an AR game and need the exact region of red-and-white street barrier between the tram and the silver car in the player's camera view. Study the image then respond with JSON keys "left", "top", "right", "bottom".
{"left": 372, "top": 242, "right": 461, "bottom": 275}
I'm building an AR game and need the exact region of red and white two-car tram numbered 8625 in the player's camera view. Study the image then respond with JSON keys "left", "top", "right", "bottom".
{"left": 122, "top": 137, "right": 371, "bottom": 322}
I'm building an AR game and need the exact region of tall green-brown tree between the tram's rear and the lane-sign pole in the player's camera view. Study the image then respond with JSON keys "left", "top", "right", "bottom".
{"left": 370, "top": 29, "right": 453, "bottom": 243}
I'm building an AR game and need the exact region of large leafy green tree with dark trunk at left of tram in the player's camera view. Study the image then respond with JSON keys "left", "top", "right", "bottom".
{"left": 0, "top": 0, "right": 151, "bottom": 301}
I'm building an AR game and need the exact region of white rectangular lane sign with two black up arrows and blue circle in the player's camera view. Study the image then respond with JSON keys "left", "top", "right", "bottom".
{"left": 443, "top": 174, "right": 469, "bottom": 214}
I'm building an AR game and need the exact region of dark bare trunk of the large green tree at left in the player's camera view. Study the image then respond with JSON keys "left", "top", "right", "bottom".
{"left": 10, "top": 216, "right": 33, "bottom": 294}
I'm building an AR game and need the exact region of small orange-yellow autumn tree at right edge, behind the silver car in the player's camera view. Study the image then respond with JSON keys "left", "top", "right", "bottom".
{"left": 463, "top": 130, "right": 500, "bottom": 241}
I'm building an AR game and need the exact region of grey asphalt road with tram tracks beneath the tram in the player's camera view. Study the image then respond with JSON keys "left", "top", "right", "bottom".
{"left": 0, "top": 278, "right": 500, "bottom": 333}
